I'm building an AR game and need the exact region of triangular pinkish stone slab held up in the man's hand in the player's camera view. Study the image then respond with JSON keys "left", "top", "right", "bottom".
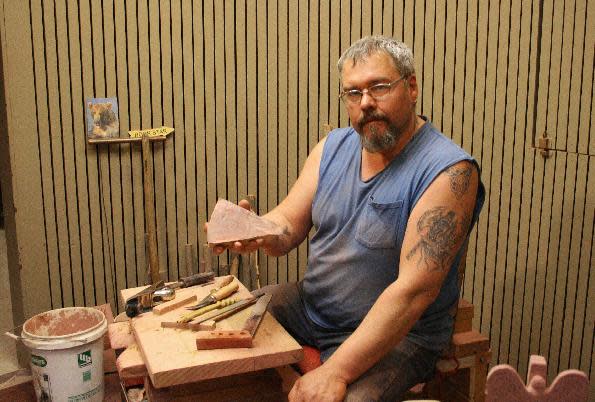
{"left": 207, "top": 199, "right": 283, "bottom": 244}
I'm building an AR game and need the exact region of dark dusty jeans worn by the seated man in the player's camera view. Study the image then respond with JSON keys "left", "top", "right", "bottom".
{"left": 254, "top": 283, "right": 440, "bottom": 402}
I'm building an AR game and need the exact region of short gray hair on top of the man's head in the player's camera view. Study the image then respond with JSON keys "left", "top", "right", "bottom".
{"left": 337, "top": 35, "right": 415, "bottom": 77}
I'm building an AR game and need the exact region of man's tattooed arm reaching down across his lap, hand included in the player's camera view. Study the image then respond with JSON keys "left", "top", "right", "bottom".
{"left": 290, "top": 162, "right": 479, "bottom": 401}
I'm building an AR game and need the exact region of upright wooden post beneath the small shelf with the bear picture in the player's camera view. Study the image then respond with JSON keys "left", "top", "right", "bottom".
{"left": 142, "top": 136, "right": 161, "bottom": 283}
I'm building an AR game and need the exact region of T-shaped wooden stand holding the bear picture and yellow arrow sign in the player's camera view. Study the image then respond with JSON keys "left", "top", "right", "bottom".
{"left": 87, "top": 132, "right": 171, "bottom": 284}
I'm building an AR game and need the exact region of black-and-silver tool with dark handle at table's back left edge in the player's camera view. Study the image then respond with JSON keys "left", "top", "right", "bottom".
{"left": 125, "top": 272, "right": 215, "bottom": 318}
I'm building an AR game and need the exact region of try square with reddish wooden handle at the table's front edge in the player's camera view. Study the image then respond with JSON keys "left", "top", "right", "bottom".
{"left": 196, "top": 293, "right": 271, "bottom": 350}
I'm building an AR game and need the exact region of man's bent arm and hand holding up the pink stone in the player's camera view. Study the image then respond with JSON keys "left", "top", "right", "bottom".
{"left": 214, "top": 138, "right": 326, "bottom": 256}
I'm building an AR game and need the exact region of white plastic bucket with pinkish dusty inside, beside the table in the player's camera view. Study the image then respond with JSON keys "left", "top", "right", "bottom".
{"left": 21, "top": 307, "right": 107, "bottom": 402}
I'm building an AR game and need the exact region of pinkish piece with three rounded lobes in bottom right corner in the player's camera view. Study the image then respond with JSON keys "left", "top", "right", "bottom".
{"left": 486, "top": 355, "right": 589, "bottom": 402}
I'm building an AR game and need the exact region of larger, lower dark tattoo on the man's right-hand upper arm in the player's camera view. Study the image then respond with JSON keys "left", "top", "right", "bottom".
{"left": 406, "top": 207, "right": 471, "bottom": 271}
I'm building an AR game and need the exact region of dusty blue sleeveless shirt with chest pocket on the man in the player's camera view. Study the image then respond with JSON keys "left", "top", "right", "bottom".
{"left": 302, "top": 119, "right": 484, "bottom": 350}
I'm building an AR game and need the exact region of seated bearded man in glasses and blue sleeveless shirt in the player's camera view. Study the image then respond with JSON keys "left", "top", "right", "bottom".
{"left": 215, "top": 37, "right": 484, "bottom": 402}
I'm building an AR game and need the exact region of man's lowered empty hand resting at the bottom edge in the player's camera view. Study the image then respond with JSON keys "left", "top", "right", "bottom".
{"left": 289, "top": 364, "right": 347, "bottom": 402}
